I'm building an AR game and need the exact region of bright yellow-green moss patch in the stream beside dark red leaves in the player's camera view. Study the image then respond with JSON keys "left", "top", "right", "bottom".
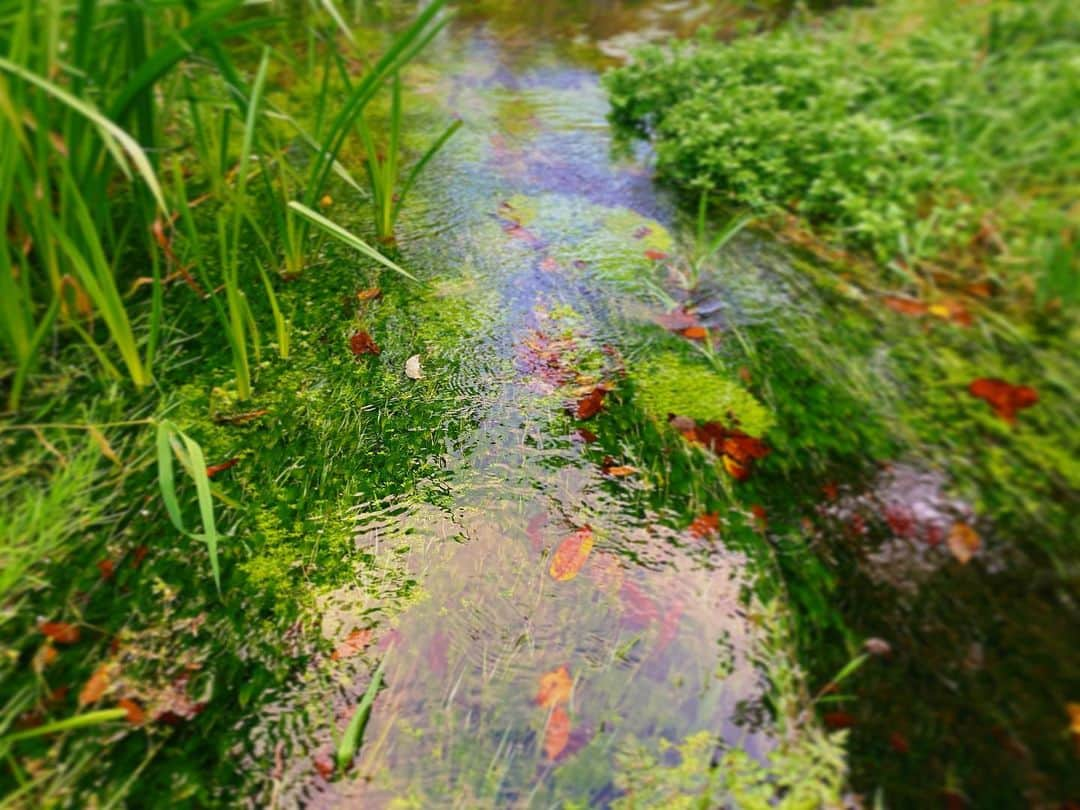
{"left": 632, "top": 352, "right": 773, "bottom": 436}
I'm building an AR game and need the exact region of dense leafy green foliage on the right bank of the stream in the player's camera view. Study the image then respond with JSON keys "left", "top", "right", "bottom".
{"left": 606, "top": 0, "right": 1080, "bottom": 296}
